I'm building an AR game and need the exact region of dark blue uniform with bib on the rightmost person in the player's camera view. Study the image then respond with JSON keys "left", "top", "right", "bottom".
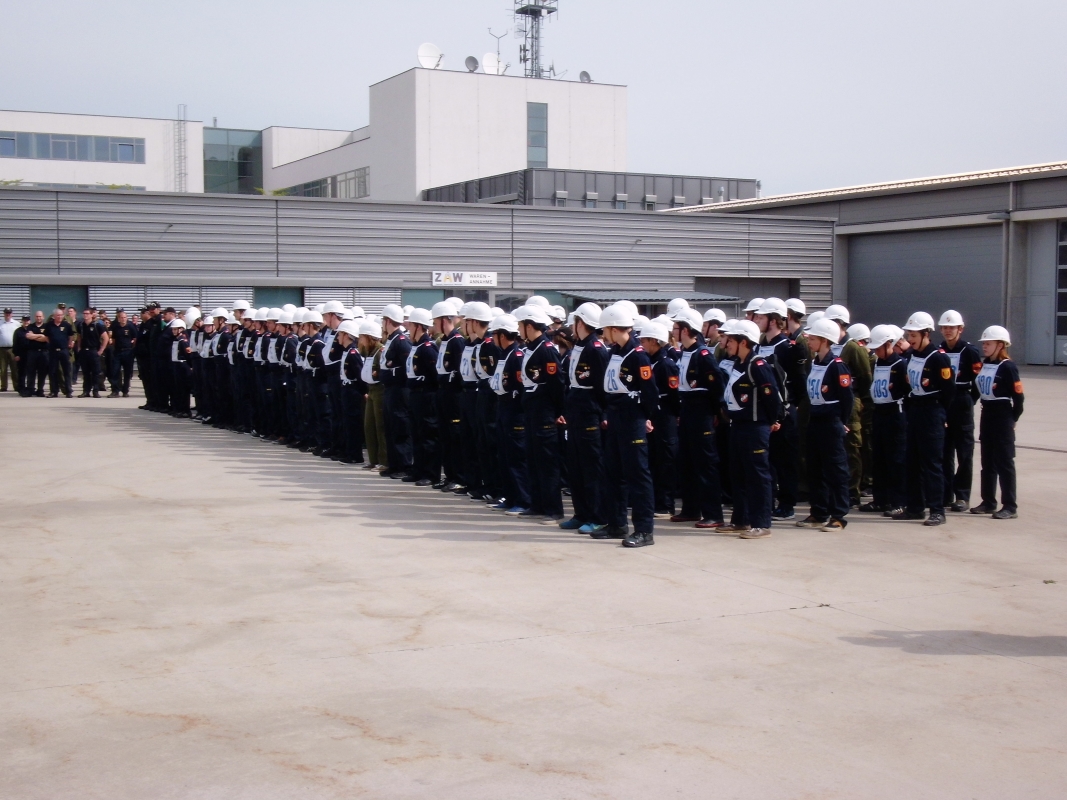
{"left": 975, "top": 358, "right": 1023, "bottom": 513}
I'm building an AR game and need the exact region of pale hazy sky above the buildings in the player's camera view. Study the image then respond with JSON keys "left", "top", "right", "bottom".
{"left": 0, "top": 0, "right": 1067, "bottom": 195}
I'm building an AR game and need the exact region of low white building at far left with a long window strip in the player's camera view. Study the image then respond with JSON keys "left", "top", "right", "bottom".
{"left": 0, "top": 111, "right": 204, "bottom": 192}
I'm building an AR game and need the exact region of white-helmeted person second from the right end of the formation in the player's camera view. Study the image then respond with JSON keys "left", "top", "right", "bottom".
{"left": 938, "top": 310, "right": 982, "bottom": 512}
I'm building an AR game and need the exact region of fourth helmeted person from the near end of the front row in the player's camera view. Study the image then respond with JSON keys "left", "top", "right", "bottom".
{"left": 489, "top": 314, "right": 530, "bottom": 516}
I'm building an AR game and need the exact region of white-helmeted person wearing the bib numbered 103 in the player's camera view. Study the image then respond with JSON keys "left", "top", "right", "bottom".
{"left": 860, "top": 325, "right": 908, "bottom": 516}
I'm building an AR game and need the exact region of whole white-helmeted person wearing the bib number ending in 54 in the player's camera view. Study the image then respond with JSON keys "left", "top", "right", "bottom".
{"left": 797, "top": 315, "right": 855, "bottom": 531}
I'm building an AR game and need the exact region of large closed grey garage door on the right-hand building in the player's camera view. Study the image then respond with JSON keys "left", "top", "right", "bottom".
{"left": 848, "top": 225, "right": 1004, "bottom": 332}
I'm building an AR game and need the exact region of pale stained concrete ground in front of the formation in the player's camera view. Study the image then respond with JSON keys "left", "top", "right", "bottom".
{"left": 0, "top": 369, "right": 1067, "bottom": 800}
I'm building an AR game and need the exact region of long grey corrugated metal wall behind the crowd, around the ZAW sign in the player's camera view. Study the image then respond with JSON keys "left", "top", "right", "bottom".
{"left": 0, "top": 190, "right": 832, "bottom": 307}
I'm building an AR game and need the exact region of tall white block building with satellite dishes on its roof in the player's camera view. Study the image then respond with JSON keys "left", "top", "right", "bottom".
{"left": 262, "top": 68, "right": 626, "bottom": 201}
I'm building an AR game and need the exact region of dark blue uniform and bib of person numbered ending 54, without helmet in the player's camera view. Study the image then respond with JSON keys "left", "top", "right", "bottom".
{"left": 806, "top": 350, "right": 856, "bottom": 522}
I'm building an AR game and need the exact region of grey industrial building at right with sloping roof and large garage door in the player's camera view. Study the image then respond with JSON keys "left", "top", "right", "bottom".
{"left": 664, "top": 162, "right": 1067, "bottom": 364}
